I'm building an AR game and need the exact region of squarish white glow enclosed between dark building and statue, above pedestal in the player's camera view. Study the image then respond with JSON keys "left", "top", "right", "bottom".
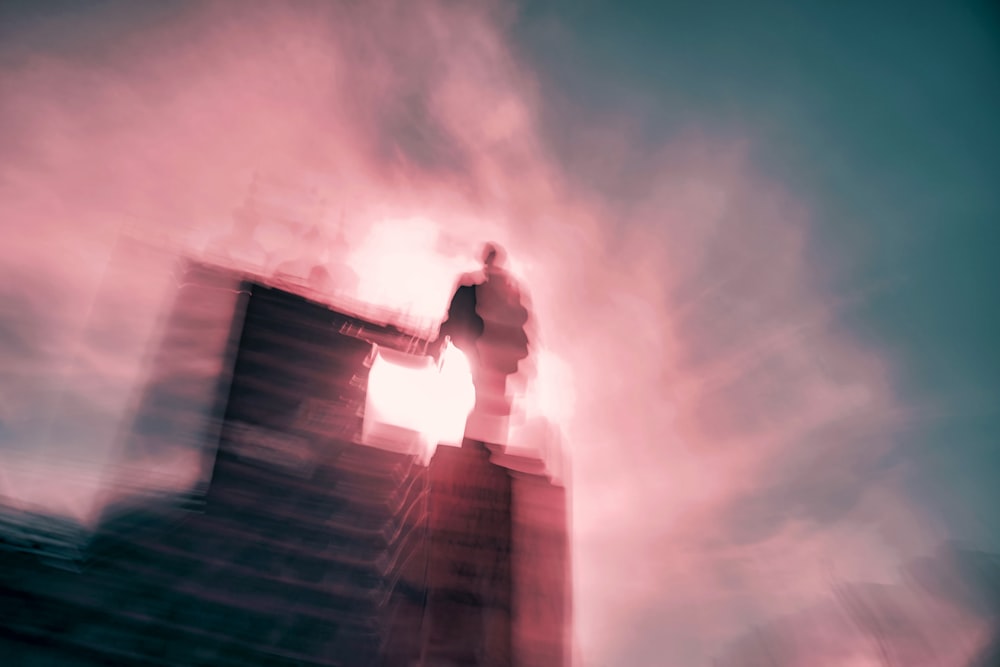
{"left": 362, "top": 344, "right": 476, "bottom": 459}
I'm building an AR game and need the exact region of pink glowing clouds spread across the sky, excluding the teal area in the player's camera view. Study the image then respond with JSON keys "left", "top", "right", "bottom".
{"left": 0, "top": 0, "right": 988, "bottom": 667}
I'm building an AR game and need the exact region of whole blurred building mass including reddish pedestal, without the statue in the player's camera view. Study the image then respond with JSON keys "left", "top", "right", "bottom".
{"left": 0, "top": 266, "right": 570, "bottom": 667}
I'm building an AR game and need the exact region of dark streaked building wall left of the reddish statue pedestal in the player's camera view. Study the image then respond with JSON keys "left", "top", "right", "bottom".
{"left": 0, "top": 286, "right": 428, "bottom": 667}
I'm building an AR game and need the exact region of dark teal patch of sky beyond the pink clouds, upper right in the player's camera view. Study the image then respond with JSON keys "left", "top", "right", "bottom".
{"left": 517, "top": 1, "right": 1000, "bottom": 542}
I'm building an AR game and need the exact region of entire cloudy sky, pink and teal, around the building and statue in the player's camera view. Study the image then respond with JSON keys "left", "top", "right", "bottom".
{"left": 0, "top": 0, "right": 1000, "bottom": 667}
